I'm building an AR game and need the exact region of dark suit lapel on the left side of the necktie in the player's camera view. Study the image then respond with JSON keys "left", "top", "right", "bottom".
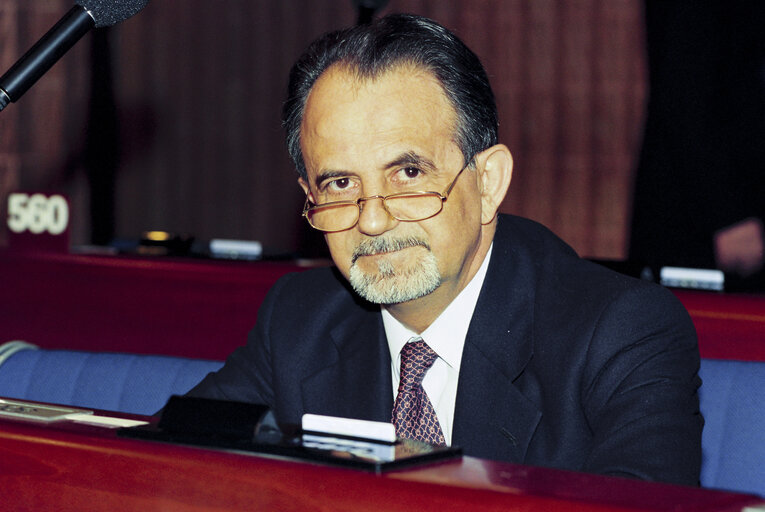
{"left": 302, "top": 311, "right": 393, "bottom": 422}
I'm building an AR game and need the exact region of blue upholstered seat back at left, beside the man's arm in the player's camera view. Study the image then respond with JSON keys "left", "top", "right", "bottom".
{"left": 0, "top": 341, "right": 223, "bottom": 415}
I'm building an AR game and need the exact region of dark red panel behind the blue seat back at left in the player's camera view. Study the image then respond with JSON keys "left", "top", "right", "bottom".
{"left": 0, "top": 254, "right": 310, "bottom": 360}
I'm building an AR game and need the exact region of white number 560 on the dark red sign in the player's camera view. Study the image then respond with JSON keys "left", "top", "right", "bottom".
{"left": 8, "top": 193, "right": 69, "bottom": 235}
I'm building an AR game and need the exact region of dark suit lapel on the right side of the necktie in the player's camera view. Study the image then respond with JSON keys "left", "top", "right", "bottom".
{"left": 452, "top": 223, "right": 542, "bottom": 462}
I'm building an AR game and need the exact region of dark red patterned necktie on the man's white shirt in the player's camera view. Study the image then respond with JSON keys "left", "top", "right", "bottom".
{"left": 392, "top": 338, "right": 446, "bottom": 446}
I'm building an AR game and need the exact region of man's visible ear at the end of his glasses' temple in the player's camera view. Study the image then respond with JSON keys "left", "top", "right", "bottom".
{"left": 476, "top": 144, "right": 513, "bottom": 224}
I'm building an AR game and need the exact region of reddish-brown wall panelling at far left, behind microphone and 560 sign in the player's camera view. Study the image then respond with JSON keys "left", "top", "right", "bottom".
{"left": 0, "top": 0, "right": 90, "bottom": 244}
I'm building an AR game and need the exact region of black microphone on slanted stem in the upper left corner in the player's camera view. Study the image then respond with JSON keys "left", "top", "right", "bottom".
{"left": 0, "top": 0, "right": 149, "bottom": 110}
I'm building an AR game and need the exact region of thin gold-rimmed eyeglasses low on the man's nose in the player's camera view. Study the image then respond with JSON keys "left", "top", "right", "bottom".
{"left": 303, "top": 160, "right": 472, "bottom": 233}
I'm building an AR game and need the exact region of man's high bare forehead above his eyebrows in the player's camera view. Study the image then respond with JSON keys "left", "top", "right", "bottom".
{"left": 301, "top": 65, "right": 461, "bottom": 175}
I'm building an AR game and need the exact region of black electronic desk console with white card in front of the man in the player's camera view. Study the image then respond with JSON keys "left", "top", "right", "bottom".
{"left": 119, "top": 396, "right": 462, "bottom": 473}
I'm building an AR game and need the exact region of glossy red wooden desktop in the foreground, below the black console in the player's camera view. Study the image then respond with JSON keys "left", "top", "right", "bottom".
{"left": 0, "top": 415, "right": 763, "bottom": 512}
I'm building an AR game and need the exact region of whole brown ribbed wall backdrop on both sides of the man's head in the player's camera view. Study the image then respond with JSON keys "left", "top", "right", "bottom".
{"left": 0, "top": 0, "right": 646, "bottom": 258}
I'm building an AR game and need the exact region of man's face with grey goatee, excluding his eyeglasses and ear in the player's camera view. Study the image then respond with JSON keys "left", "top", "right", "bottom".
{"left": 301, "top": 66, "right": 481, "bottom": 312}
